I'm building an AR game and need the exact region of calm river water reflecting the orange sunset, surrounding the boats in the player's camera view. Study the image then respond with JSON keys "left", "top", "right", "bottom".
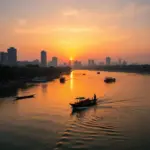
{"left": 0, "top": 71, "right": 150, "bottom": 150}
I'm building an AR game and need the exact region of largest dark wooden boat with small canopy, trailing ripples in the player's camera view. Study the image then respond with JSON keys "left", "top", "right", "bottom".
{"left": 70, "top": 97, "right": 97, "bottom": 110}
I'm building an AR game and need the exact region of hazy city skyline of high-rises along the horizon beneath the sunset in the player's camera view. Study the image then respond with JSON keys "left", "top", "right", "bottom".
{"left": 0, "top": 47, "right": 129, "bottom": 68}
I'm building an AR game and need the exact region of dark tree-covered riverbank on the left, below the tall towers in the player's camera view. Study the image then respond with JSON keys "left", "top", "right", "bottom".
{"left": 0, "top": 65, "right": 71, "bottom": 96}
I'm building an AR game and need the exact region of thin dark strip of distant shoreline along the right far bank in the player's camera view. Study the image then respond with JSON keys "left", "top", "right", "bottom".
{"left": 82, "top": 64, "right": 150, "bottom": 74}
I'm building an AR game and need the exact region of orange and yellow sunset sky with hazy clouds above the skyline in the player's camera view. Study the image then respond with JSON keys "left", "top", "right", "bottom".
{"left": 0, "top": 0, "right": 150, "bottom": 63}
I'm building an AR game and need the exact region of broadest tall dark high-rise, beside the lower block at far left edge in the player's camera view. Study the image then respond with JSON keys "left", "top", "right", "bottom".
{"left": 7, "top": 47, "right": 17, "bottom": 66}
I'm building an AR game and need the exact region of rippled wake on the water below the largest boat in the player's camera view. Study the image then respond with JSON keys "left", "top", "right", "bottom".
{"left": 55, "top": 104, "right": 122, "bottom": 150}
